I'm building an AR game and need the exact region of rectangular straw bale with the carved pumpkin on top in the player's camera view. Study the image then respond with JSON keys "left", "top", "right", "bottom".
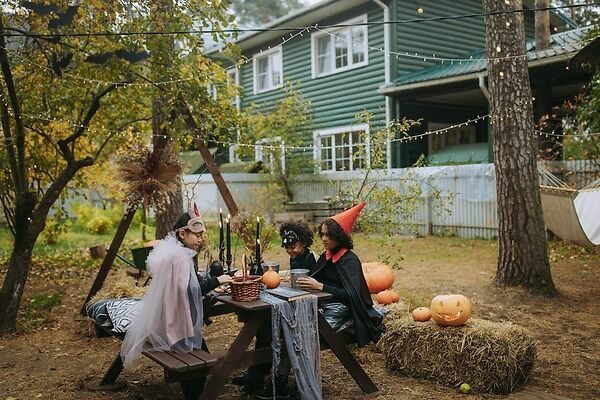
{"left": 378, "top": 316, "right": 536, "bottom": 394}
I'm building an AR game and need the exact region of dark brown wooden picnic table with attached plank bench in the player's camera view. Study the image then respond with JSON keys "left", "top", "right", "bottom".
{"left": 93, "top": 291, "right": 378, "bottom": 400}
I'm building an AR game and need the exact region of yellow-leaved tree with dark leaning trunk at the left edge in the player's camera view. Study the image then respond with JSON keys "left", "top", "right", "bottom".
{"left": 0, "top": 0, "right": 236, "bottom": 333}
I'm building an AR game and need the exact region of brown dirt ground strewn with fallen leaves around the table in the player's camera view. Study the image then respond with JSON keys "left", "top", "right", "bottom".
{"left": 0, "top": 235, "right": 600, "bottom": 400}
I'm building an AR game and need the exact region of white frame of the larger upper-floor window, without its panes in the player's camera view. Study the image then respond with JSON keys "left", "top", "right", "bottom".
{"left": 310, "top": 14, "right": 369, "bottom": 79}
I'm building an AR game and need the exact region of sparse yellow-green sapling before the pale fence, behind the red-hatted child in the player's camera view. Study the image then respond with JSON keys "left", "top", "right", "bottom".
{"left": 330, "top": 110, "right": 452, "bottom": 267}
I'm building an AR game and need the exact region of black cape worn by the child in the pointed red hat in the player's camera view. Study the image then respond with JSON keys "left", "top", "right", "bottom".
{"left": 310, "top": 250, "right": 385, "bottom": 346}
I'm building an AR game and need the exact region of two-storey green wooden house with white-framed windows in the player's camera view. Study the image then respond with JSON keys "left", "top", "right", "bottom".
{"left": 211, "top": 0, "right": 586, "bottom": 173}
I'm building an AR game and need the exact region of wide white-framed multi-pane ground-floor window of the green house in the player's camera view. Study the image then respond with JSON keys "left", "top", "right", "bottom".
{"left": 314, "top": 124, "right": 369, "bottom": 172}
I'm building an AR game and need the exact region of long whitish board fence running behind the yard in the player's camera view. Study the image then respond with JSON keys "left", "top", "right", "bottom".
{"left": 184, "top": 161, "right": 600, "bottom": 238}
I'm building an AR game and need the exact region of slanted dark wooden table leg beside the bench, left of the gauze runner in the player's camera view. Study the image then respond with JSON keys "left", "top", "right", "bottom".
{"left": 199, "top": 310, "right": 270, "bottom": 400}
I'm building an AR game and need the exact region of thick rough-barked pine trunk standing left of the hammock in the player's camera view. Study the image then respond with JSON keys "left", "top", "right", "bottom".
{"left": 484, "top": 0, "right": 556, "bottom": 295}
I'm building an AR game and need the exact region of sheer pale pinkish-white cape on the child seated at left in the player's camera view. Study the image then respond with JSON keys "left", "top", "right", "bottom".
{"left": 121, "top": 232, "right": 203, "bottom": 368}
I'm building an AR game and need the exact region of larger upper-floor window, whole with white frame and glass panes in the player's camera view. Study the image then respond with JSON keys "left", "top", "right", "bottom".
{"left": 311, "top": 15, "right": 369, "bottom": 78}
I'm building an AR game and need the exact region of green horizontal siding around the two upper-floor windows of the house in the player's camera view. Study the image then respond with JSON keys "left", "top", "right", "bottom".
{"left": 240, "top": 3, "right": 385, "bottom": 139}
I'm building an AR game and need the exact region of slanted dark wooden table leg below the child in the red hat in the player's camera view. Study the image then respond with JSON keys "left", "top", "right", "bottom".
{"left": 318, "top": 313, "right": 378, "bottom": 394}
